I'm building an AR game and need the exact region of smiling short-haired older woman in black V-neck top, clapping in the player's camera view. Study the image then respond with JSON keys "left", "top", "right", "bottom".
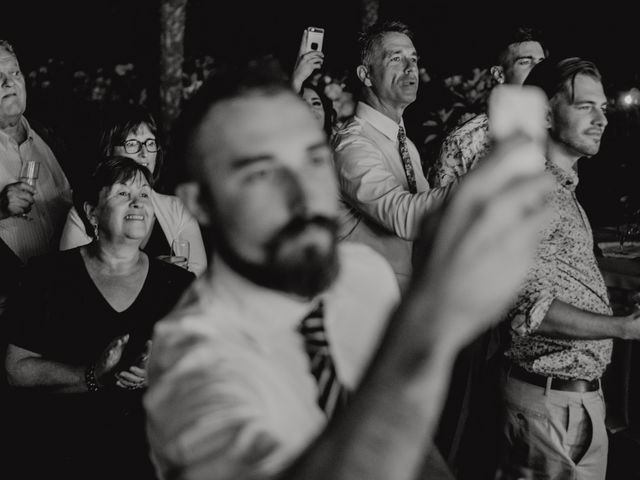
{"left": 6, "top": 157, "right": 194, "bottom": 479}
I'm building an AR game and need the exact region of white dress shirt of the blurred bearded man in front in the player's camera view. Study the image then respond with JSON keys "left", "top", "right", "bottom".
{"left": 144, "top": 243, "right": 399, "bottom": 480}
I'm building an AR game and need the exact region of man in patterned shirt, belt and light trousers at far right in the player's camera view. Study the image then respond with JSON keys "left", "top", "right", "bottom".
{"left": 502, "top": 58, "right": 640, "bottom": 479}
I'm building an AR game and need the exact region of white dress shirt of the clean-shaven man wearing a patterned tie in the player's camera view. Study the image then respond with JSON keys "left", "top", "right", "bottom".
{"left": 333, "top": 102, "right": 449, "bottom": 288}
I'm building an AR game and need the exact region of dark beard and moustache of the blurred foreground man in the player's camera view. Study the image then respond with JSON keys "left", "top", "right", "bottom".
{"left": 214, "top": 216, "right": 340, "bottom": 298}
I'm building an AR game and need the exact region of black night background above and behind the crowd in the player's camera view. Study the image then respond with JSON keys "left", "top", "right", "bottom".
{"left": 5, "top": 0, "right": 640, "bottom": 224}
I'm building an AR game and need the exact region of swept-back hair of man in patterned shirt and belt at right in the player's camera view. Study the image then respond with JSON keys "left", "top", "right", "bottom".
{"left": 524, "top": 57, "right": 602, "bottom": 103}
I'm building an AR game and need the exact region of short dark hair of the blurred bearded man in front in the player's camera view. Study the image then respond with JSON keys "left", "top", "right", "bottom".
{"left": 173, "top": 57, "right": 295, "bottom": 183}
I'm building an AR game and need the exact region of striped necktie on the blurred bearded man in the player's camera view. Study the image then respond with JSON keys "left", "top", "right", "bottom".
{"left": 299, "top": 301, "right": 348, "bottom": 418}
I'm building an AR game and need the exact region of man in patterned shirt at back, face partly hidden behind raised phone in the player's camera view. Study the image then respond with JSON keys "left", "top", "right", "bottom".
{"left": 431, "top": 27, "right": 547, "bottom": 187}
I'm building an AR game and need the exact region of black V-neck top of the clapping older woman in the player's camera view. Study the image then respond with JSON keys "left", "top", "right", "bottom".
{"left": 4, "top": 248, "right": 195, "bottom": 478}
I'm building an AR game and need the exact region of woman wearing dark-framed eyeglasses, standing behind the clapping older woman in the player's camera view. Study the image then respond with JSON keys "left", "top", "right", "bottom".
{"left": 60, "top": 106, "right": 207, "bottom": 275}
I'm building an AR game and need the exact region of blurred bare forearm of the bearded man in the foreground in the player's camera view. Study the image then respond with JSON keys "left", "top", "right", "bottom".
{"left": 280, "top": 296, "right": 456, "bottom": 480}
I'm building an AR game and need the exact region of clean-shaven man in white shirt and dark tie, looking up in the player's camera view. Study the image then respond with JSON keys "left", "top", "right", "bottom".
{"left": 333, "top": 22, "right": 448, "bottom": 290}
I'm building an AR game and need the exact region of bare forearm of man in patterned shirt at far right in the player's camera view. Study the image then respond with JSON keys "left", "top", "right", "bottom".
{"left": 537, "top": 300, "right": 631, "bottom": 340}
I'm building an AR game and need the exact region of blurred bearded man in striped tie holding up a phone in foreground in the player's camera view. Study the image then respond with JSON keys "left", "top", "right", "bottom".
{"left": 145, "top": 59, "right": 550, "bottom": 480}
